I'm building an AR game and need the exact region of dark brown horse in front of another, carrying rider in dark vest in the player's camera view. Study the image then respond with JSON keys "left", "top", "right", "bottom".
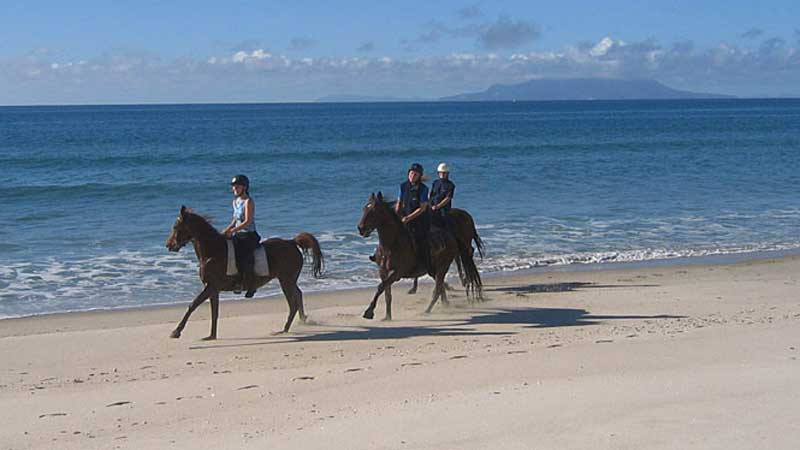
{"left": 358, "top": 192, "right": 481, "bottom": 320}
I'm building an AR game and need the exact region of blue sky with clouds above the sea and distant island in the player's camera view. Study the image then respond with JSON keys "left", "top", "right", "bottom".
{"left": 0, "top": 0, "right": 800, "bottom": 105}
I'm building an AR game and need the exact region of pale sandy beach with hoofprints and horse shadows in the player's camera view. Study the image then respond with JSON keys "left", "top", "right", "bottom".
{"left": 0, "top": 257, "right": 800, "bottom": 450}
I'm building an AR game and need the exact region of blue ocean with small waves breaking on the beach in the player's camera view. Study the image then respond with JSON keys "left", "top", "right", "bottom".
{"left": 0, "top": 100, "right": 800, "bottom": 318}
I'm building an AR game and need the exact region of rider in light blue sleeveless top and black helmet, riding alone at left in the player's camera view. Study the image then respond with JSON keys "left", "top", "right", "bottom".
{"left": 222, "top": 175, "right": 261, "bottom": 298}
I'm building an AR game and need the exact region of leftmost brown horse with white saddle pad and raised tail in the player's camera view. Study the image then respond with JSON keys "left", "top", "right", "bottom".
{"left": 166, "top": 206, "right": 323, "bottom": 340}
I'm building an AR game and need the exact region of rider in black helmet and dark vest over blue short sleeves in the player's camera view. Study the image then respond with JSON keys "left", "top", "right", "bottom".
{"left": 395, "top": 163, "right": 430, "bottom": 268}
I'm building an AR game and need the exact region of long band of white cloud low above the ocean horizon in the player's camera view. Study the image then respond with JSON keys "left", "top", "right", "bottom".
{"left": 0, "top": 36, "right": 800, "bottom": 104}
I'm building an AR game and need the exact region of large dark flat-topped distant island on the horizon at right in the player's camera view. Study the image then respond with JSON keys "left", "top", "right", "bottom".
{"left": 439, "top": 78, "right": 736, "bottom": 102}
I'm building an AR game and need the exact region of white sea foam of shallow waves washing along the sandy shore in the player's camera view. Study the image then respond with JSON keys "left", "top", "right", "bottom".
{"left": 0, "top": 239, "right": 800, "bottom": 318}
